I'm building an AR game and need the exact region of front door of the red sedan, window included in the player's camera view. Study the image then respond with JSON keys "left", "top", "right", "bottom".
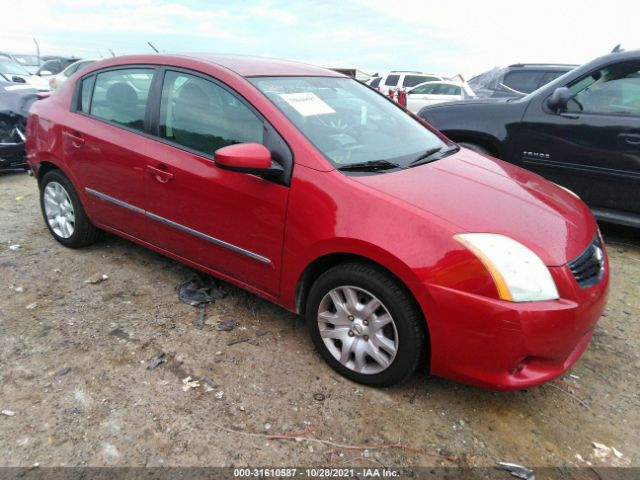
{"left": 145, "top": 70, "right": 290, "bottom": 295}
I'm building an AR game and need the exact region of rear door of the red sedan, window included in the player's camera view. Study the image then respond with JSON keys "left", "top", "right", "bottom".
{"left": 62, "top": 68, "right": 154, "bottom": 238}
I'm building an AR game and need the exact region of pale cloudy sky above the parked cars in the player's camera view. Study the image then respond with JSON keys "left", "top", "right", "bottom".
{"left": 0, "top": 0, "right": 640, "bottom": 78}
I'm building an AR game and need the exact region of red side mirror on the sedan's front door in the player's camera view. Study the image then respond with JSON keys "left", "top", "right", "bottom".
{"left": 214, "top": 143, "right": 284, "bottom": 178}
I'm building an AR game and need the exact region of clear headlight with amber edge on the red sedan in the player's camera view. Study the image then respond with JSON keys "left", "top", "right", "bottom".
{"left": 453, "top": 233, "right": 559, "bottom": 302}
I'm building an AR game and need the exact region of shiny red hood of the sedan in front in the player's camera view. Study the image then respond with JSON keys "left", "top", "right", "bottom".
{"left": 351, "top": 149, "right": 596, "bottom": 266}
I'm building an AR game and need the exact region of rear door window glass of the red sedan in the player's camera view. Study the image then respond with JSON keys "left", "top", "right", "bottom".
{"left": 88, "top": 68, "right": 154, "bottom": 130}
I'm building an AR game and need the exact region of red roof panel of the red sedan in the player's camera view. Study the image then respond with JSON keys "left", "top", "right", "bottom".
{"left": 90, "top": 53, "right": 346, "bottom": 77}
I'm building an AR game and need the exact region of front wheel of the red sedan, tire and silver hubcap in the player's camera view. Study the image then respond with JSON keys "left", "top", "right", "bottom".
{"left": 305, "top": 263, "right": 427, "bottom": 387}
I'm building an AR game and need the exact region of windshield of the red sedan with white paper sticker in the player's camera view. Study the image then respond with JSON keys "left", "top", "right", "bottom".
{"left": 249, "top": 77, "right": 446, "bottom": 168}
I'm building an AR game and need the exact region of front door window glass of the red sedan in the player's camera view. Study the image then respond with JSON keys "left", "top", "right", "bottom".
{"left": 160, "top": 71, "right": 264, "bottom": 156}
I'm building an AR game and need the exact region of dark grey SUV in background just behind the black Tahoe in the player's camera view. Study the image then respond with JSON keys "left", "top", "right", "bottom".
{"left": 469, "top": 63, "right": 577, "bottom": 98}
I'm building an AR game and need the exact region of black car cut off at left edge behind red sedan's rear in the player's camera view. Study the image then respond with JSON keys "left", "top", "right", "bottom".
{"left": 0, "top": 82, "right": 38, "bottom": 171}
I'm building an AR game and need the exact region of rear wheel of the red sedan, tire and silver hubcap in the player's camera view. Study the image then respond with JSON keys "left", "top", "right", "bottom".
{"left": 40, "top": 170, "right": 100, "bottom": 248}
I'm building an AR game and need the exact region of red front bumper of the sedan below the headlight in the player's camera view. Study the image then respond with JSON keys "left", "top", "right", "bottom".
{"left": 427, "top": 263, "right": 609, "bottom": 391}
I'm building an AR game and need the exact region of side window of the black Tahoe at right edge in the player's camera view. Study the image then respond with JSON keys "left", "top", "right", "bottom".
{"left": 567, "top": 62, "right": 640, "bottom": 116}
